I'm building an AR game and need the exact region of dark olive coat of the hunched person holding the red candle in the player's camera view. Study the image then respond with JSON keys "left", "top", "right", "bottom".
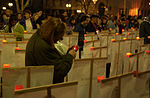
{"left": 25, "top": 31, "right": 73, "bottom": 83}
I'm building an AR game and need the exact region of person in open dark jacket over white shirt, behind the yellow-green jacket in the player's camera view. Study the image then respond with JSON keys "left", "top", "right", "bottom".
{"left": 20, "top": 10, "right": 37, "bottom": 32}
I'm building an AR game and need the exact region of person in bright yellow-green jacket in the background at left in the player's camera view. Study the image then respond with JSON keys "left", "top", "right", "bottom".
{"left": 6, "top": 14, "right": 24, "bottom": 41}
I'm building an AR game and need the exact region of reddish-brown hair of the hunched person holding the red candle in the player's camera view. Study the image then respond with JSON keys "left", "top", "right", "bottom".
{"left": 41, "top": 17, "right": 66, "bottom": 48}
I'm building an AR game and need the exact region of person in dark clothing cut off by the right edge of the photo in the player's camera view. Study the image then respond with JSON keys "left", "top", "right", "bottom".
{"left": 139, "top": 17, "right": 150, "bottom": 44}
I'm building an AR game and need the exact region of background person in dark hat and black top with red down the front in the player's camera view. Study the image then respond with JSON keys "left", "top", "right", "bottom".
{"left": 86, "top": 15, "right": 101, "bottom": 33}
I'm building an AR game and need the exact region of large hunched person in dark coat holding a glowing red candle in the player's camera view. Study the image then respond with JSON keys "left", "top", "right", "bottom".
{"left": 25, "top": 18, "right": 76, "bottom": 84}
